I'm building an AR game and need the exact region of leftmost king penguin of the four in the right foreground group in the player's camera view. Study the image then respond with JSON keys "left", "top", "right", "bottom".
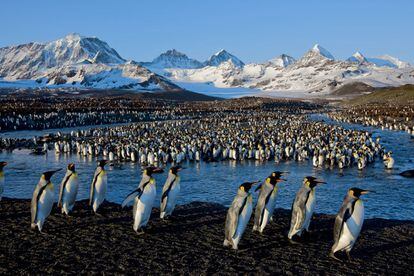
{"left": 223, "top": 181, "right": 258, "bottom": 250}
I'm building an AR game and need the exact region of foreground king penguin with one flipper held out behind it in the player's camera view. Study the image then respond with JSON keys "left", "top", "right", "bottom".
{"left": 122, "top": 167, "right": 163, "bottom": 234}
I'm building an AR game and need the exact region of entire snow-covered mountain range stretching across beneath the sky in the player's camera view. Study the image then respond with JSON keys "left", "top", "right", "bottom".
{"left": 0, "top": 34, "right": 414, "bottom": 97}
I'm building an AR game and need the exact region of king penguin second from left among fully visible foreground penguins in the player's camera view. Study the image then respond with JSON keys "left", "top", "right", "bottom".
{"left": 58, "top": 163, "right": 78, "bottom": 215}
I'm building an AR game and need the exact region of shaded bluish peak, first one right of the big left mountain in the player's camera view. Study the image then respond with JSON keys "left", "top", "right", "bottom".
{"left": 142, "top": 49, "right": 203, "bottom": 69}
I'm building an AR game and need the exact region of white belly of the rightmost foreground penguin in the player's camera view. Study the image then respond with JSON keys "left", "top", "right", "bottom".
{"left": 334, "top": 200, "right": 364, "bottom": 252}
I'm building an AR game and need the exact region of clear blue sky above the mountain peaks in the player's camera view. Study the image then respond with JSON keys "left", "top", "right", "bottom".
{"left": 0, "top": 0, "right": 414, "bottom": 63}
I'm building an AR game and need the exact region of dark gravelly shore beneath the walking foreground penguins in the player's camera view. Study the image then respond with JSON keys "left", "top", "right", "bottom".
{"left": 0, "top": 198, "right": 414, "bottom": 275}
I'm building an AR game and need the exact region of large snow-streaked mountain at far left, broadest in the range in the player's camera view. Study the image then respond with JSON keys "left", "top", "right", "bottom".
{"left": 0, "top": 34, "right": 181, "bottom": 90}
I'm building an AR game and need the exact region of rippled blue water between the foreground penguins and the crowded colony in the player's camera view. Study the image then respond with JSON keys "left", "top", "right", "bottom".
{"left": 0, "top": 115, "right": 414, "bottom": 220}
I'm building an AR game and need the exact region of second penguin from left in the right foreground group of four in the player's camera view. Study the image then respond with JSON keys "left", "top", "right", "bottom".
{"left": 253, "top": 172, "right": 285, "bottom": 233}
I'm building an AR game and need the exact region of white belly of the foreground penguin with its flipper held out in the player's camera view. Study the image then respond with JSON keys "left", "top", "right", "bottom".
{"left": 134, "top": 184, "right": 156, "bottom": 231}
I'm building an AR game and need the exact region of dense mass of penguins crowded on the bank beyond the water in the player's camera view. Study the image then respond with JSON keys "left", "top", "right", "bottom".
{"left": 0, "top": 111, "right": 392, "bottom": 170}
